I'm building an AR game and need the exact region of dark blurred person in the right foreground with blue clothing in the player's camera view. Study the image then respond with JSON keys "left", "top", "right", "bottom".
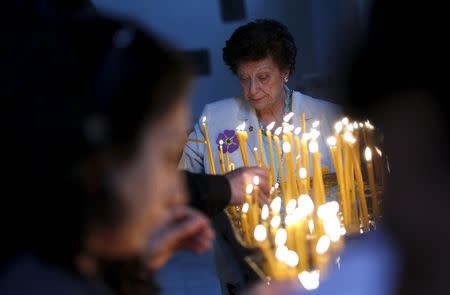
{"left": 246, "top": 0, "right": 450, "bottom": 295}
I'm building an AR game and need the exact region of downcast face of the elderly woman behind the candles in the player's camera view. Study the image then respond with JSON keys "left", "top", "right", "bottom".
{"left": 238, "top": 56, "right": 289, "bottom": 111}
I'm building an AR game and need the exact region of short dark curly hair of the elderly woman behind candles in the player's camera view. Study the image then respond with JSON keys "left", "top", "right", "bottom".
{"left": 222, "top": 19, "right": 297, "bottom": 74}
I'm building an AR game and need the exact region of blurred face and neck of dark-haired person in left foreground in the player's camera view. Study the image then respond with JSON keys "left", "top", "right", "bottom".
{"left": 91, "top": 98, "right": 189, "bottom": 258}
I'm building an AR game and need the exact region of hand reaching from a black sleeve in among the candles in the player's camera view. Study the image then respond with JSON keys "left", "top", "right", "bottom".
{"left": 225, "top": 167, "right": 270, "bottom": 206}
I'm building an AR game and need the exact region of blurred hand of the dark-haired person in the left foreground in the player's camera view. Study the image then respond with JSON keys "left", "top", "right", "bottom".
{"left": 146, "top": 206, "right": 214, "bottom": 270}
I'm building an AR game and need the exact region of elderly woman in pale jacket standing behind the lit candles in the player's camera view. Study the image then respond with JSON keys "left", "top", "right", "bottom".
{"left": 181, "top": 20, "right": 339, "bottom": 290}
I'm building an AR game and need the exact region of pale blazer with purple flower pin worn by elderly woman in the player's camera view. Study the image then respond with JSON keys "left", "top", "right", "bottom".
{"left": 180, "top": 91, "right": 342, "bottom": 174}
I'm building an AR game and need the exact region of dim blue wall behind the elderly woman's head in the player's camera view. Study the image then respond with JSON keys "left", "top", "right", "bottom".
{"left": 93, "top": 0, "right": 370, "bottom": 118}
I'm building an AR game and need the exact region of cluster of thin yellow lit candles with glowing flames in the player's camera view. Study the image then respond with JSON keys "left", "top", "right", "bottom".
{"left": 198, "top": 113, "right": 384, "bottom": 289}
